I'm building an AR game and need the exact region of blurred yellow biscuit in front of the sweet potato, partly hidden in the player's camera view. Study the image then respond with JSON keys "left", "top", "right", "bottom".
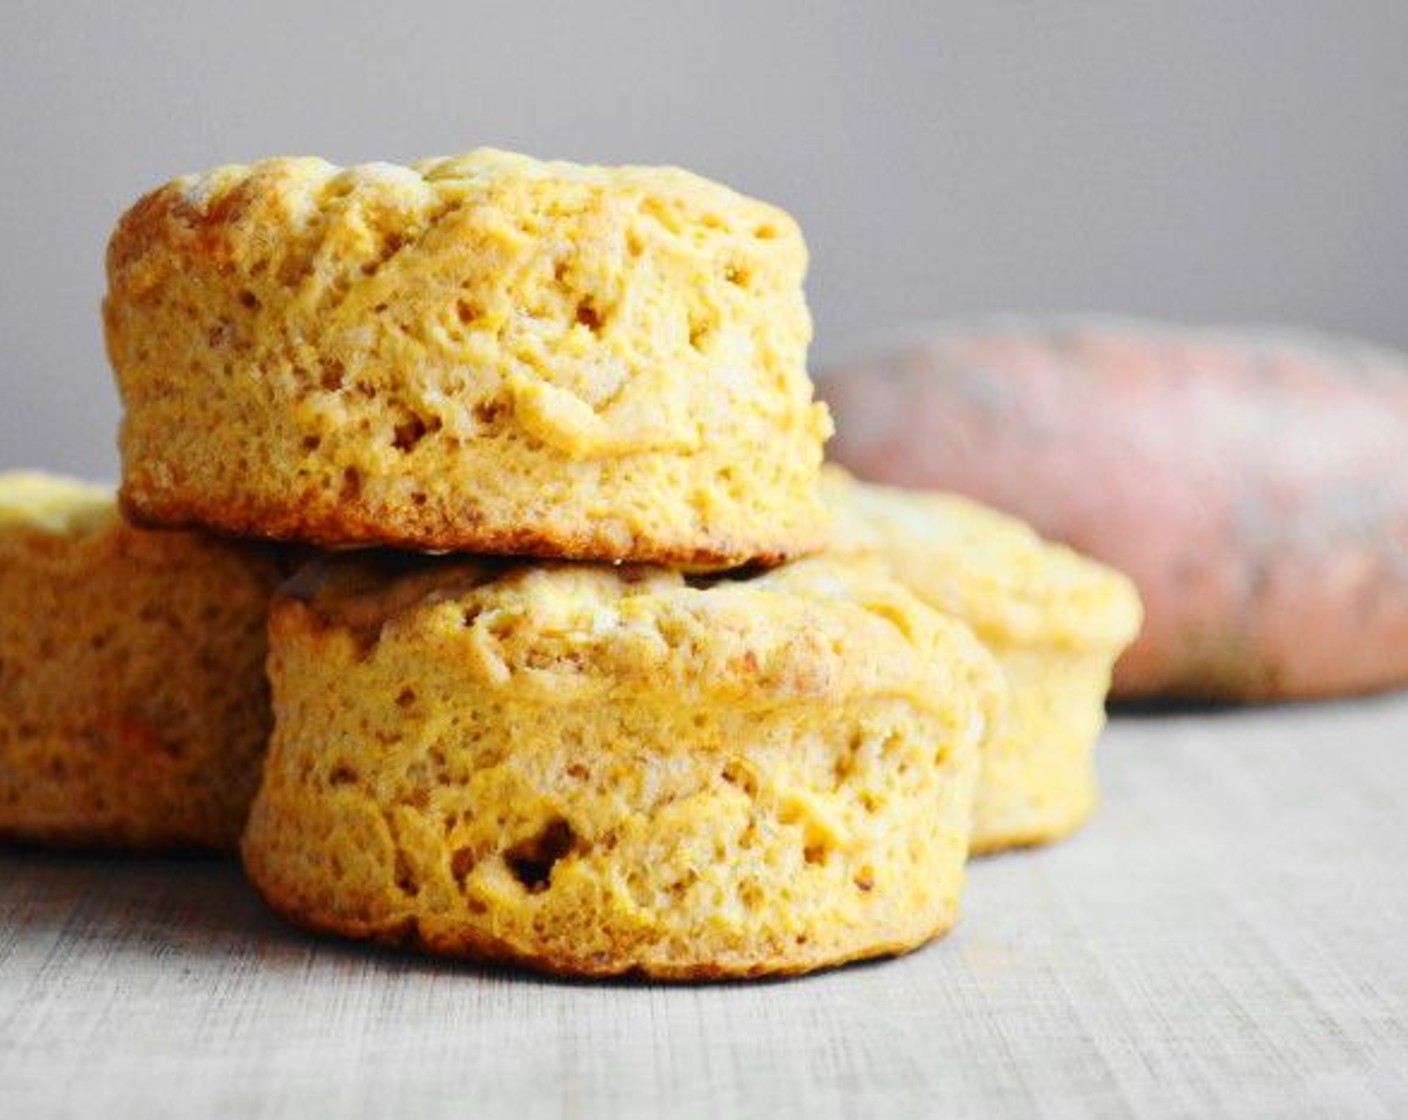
{"left": 824, "top": 466, "right": 1140, "bottom": 852}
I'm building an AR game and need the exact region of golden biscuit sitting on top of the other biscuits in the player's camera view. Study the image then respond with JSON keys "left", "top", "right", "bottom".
{"left": 112, "top": 149, "right": 831, "bottom": 568}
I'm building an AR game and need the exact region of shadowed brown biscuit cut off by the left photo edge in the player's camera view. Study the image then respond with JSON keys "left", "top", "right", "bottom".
{"left": 0, "top": 473, "right": 280, "bottom": 850}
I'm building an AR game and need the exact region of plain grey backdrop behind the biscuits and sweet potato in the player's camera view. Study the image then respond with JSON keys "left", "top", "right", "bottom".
{"left": 0, "top": 0, "right": 1408, "bottom": 478}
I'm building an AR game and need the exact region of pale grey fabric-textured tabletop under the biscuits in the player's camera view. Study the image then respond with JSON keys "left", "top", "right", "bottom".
{"left": 0, "top": 695, "right": 1408, "bottom": 1120}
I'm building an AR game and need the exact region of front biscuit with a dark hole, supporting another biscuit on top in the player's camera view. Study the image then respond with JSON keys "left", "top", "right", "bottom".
{"left": 244, "top": 559, "right": 1001, "bottom": 979}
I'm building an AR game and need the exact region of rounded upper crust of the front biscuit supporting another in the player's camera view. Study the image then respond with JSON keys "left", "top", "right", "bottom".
{"left": 273, "top": 554, "right": 1000, "bottom": 727}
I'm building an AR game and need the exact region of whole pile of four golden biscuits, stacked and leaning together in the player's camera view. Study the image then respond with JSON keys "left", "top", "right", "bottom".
{"left": 0, "top": 151, "right": 1138, "bottom": 978}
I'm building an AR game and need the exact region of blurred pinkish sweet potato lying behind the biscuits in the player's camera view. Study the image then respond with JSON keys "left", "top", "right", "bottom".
{"left": 821, "top": 321, "right": 1408, "bottom": 700}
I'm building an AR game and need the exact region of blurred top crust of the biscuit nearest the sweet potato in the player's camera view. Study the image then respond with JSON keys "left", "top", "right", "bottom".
{"left": 822, "top": 465, "right": 1142, "bottom": 649}
